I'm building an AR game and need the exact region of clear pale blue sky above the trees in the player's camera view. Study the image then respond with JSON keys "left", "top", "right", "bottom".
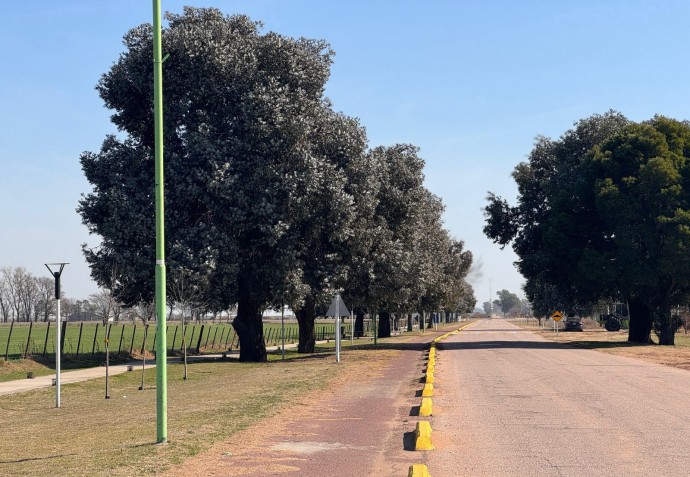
{"left": 0, "top": 0, "right": 690, "bottom": 303}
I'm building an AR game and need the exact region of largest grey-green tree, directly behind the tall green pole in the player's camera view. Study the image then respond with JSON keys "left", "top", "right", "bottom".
{"left": 78, "top": 7, "right": 360, "bottom": 361}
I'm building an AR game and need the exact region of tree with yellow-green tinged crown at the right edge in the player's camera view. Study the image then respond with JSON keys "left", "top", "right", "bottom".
{"left": 580, "top": 116, "right": 690, "bottom": 345}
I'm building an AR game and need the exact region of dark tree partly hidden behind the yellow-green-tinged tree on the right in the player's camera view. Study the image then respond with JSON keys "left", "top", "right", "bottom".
{"left": 484, "top": 111, "right": 632, "bottom": 334}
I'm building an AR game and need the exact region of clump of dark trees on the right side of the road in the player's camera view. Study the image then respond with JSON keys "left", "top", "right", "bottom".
{"left": 484, "top": 112, "right": 690, "bottom": 344}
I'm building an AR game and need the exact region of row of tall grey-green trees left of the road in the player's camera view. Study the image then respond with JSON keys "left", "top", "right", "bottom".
{"left": 78, "top": 7, "right": 474, "bottom": 361}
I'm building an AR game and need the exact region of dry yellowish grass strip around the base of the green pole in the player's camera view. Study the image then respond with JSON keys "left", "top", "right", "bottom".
{"left": 0, "top": 324, "right": 444, "bottom": 477}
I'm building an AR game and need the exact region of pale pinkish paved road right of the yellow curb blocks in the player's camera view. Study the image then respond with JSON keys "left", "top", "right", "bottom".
{"left": 428, "top": 319, "right": 690, "bottom": 477}
